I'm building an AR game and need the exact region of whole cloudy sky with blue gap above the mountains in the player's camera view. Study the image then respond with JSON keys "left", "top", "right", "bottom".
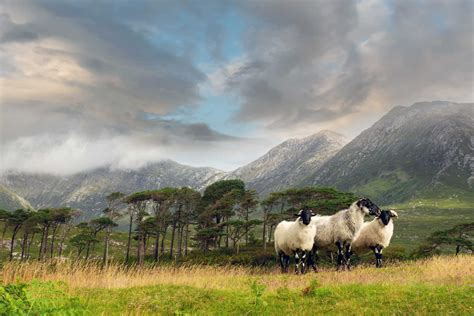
{"left": 0, "top": 0, "right": 474, "bottom": 175}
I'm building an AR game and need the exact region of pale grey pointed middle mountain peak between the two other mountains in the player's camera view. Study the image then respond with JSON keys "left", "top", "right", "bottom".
{"left": 226, "top": 131, "right": 347, "bottom": 194}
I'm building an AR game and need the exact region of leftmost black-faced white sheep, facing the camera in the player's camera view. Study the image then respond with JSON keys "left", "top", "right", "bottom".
{"left": 274, "top": 209, "right": 316, "bottom": 274}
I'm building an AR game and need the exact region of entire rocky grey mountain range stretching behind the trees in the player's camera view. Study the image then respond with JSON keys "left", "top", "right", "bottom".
{"left": 0, "top": 101, "right": 474, "bottom": 216}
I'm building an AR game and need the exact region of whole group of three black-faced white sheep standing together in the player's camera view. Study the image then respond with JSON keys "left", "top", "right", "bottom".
{"left": 275, "top": 198, "right": 398, "bottom": 273}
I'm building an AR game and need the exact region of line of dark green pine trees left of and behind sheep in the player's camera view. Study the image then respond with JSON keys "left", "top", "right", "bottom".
{"left": 0, "top": 180, "right": 356, "bottom": 265}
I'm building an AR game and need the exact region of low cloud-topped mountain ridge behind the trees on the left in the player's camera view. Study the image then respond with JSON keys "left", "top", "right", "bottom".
{"left": 0, "top": 160, "right": 223, "bottom": 217}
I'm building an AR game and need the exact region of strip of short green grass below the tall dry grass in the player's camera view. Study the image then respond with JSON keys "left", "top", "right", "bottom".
{"left": 6, "top": 281, "right": 474, "bottom": 315}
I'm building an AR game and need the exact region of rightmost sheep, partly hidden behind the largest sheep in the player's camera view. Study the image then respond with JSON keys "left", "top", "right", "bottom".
{"left": 352, "top": 210, "right": 398, "bottom": 268}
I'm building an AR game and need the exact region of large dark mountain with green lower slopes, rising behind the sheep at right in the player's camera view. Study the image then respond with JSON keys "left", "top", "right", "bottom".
{"left": 305, "top": 101, "right": 474, "bottom": 203}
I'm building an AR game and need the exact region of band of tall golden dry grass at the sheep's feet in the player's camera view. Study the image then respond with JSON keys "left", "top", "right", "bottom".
{"left": 1, "top": 255, "right": 474, "bottom": 290}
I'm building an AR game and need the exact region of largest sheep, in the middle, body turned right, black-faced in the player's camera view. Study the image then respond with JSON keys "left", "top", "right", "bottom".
{"left": 308, "top": 198, "right": 380, "bottom": 272}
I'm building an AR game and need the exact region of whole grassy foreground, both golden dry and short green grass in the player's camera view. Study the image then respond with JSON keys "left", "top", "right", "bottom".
{"left": 0, "top": 256, "right": 474, "bottom": 315}
